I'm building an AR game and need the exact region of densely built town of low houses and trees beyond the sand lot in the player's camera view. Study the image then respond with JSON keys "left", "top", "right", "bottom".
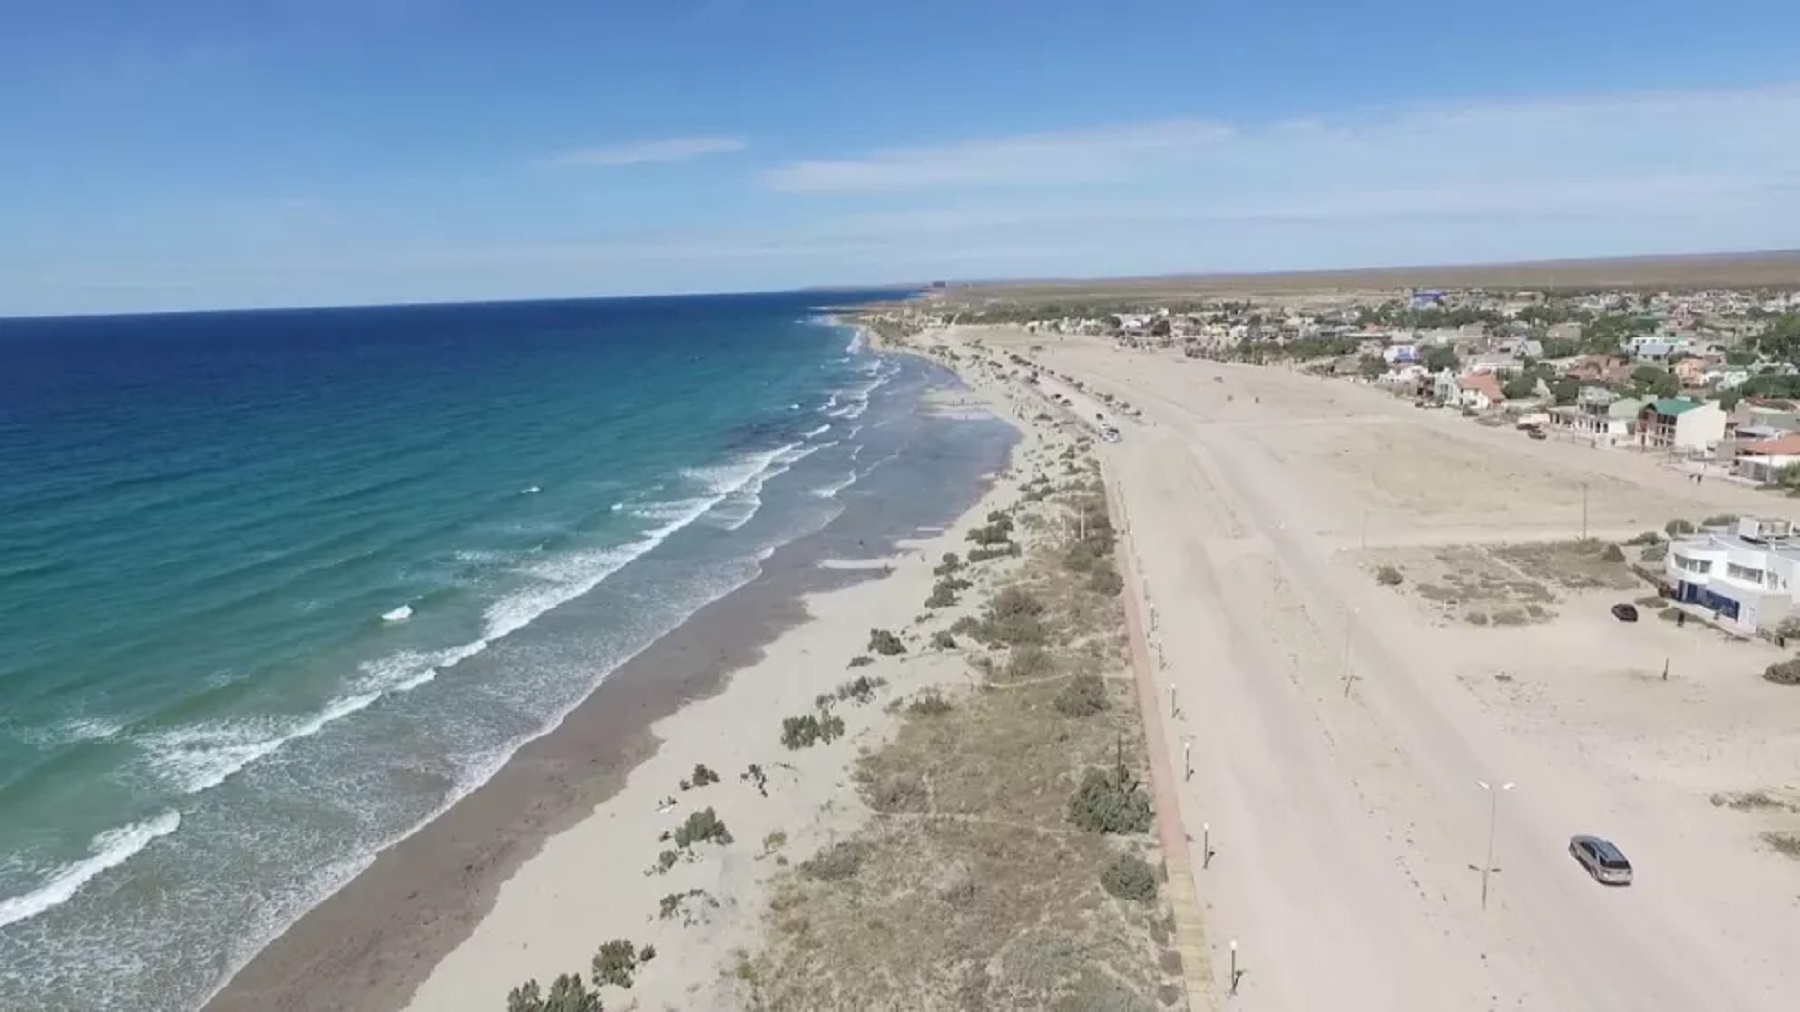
{"left": 900, "top": 280, "right": 1800, "bottom": 488}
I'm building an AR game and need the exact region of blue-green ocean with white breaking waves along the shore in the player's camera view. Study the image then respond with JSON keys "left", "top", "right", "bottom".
{"left": 0, "top": 294, "right": 979, "bottom": 1010}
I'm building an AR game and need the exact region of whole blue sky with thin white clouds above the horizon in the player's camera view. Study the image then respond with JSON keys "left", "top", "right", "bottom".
{"left": 0, "top": 0, "right": 1800, "bottom": 313}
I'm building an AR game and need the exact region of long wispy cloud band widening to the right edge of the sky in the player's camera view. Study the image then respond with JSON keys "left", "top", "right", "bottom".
{"left": 763, "top": 86, "right": 1800, "bottom": 205}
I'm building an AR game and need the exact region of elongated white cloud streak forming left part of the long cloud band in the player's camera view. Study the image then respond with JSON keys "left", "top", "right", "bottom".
{"left": 763, "top": 121, "right": 1233, "bottom": 193}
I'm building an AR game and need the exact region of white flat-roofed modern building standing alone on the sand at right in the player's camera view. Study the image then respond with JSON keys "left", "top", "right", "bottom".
{"left": 1663, "top": 517, "right": 1800, "bottom": 634}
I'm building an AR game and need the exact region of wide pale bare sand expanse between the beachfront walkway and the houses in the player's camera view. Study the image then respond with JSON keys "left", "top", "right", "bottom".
{"left": 922, "top": 328, "right": 1800, "bottom": 1012}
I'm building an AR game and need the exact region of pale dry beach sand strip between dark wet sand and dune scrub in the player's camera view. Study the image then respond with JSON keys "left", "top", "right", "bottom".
{"left": 392, "top": 385, "right": 1035, "bottom": 1012}
